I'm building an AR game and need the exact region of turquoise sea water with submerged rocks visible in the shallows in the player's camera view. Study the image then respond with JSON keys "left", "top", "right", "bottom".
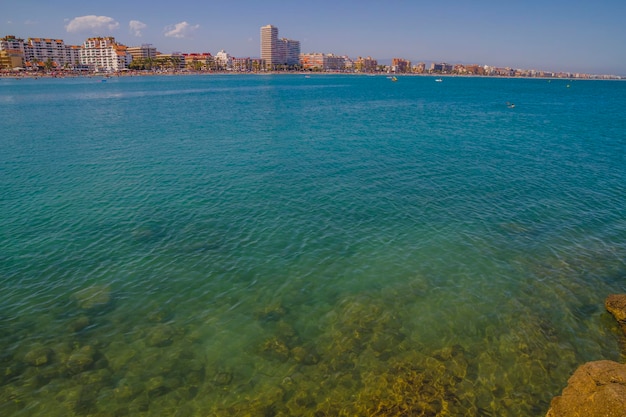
{"left": 0, "top": 75, "right": 626, "bottom": 417}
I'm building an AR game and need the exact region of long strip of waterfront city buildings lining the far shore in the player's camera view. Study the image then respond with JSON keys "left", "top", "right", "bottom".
{"left": 0, "top": 25, "right": 623, "bottom": 79}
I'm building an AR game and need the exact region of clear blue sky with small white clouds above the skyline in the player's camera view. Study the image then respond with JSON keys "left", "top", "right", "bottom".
{"left": 0, "top": 0, "right": 626, "bottom": 75}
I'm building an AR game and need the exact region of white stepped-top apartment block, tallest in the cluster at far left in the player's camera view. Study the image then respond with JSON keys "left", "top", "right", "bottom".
{"left": 80, "top": 36, "right": 132, "bottom": 72}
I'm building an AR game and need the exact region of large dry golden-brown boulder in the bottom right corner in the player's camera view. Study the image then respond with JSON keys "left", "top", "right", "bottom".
{"left": 546, "top": 360, "right": 626, "bottom": 417}
